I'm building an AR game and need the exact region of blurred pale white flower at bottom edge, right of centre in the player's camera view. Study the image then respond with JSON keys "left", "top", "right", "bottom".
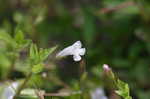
{"left": 91, "top": 88, "right": 108, "bottom": 99}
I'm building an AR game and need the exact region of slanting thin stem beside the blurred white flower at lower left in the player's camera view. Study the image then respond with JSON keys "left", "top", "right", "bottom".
{"left": 13, "top": 72, "right": 32, "bottom": 99}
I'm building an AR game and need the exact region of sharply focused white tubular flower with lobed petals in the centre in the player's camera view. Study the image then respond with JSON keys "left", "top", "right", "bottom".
{"left": 56, "top": 41, "right": 86, "bottom": 61}
